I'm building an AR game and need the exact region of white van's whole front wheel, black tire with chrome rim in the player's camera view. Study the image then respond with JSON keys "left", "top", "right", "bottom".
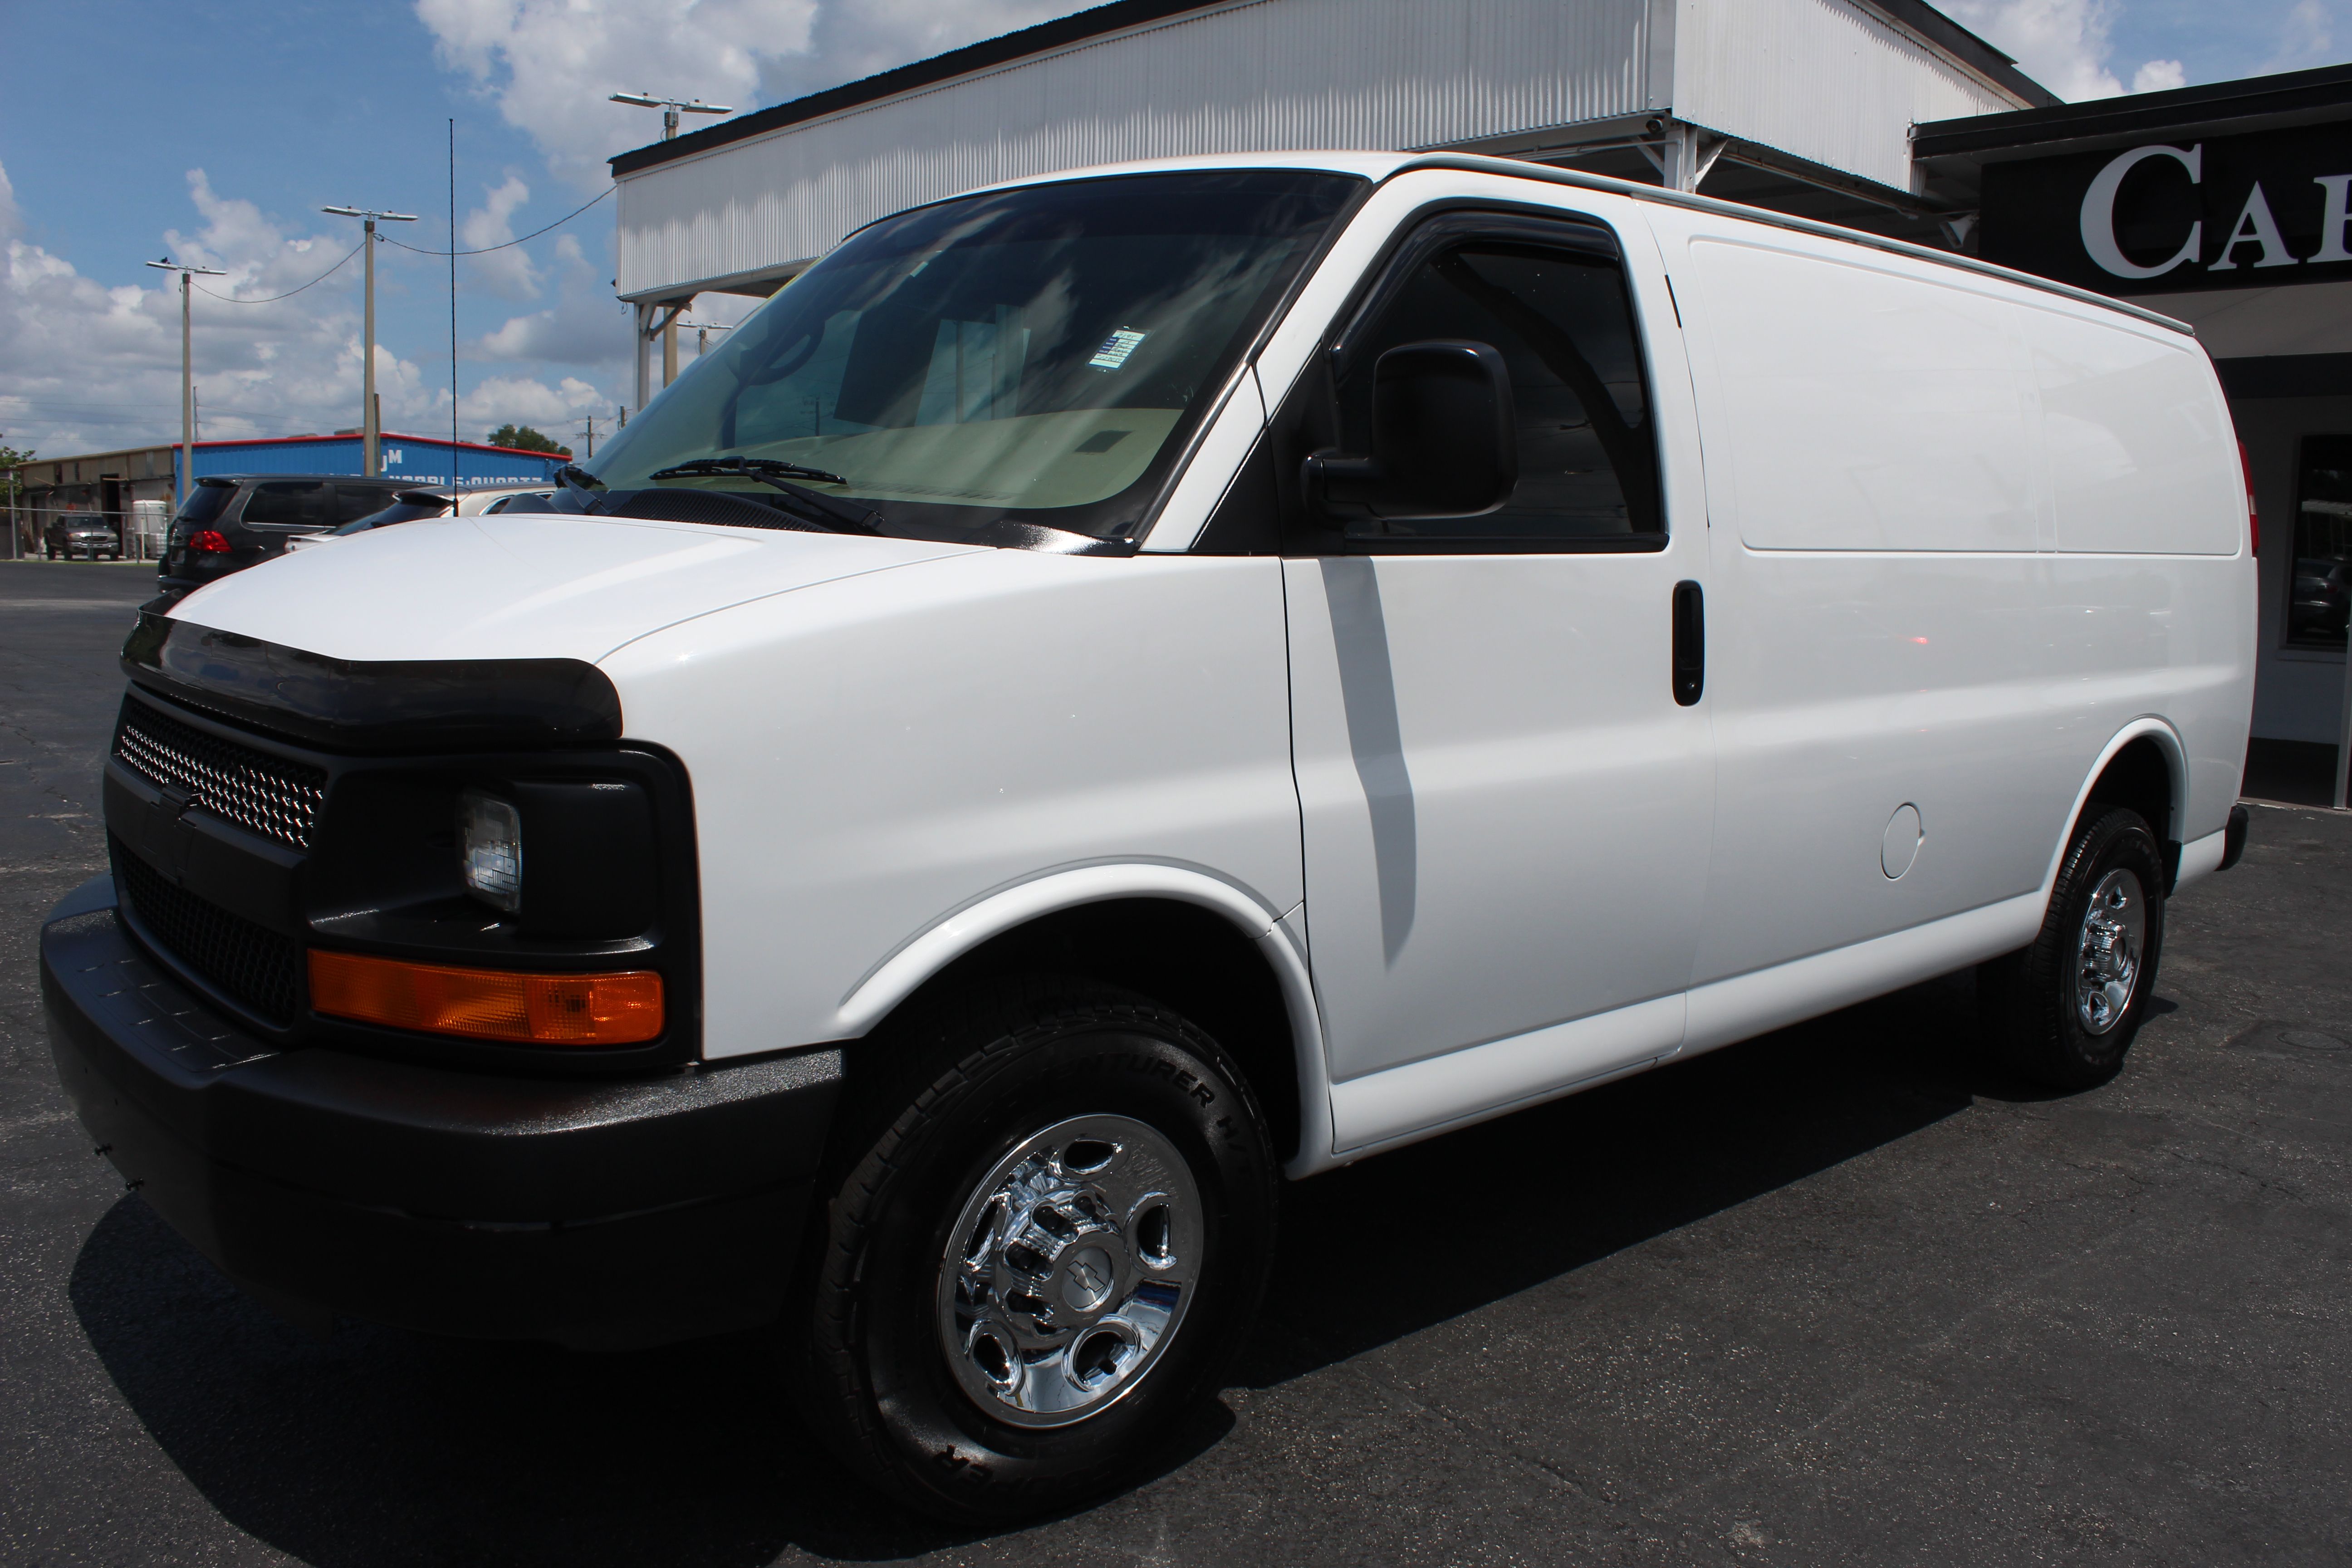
{"left": 797, "top": 983, "right": 1277, "bottom": 1524}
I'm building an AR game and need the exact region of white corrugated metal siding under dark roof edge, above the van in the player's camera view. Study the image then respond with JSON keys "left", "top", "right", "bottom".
{"left": 618, "top": 0, "right": 2023, "bottom": 299}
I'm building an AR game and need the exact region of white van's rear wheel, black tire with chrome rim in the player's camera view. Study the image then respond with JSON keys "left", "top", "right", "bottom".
{"left": 1976, "top": 806, "right": 2164, "bottom": 1088}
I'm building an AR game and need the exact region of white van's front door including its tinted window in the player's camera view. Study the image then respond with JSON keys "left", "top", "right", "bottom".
{"left": 1270, "top": 211, "right": 1712, "bottom": 1152}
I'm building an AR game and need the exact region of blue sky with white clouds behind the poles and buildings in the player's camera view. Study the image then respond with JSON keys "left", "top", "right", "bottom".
{"left": 0, "top": 0, "right": 2352, "bottom": 456}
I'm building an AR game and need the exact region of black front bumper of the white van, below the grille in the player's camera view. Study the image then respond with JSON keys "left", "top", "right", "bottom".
{"left": 40, "top": 877, "right": 842, "bottom": 1347}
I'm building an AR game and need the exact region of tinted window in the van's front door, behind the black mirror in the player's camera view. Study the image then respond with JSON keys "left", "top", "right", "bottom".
{"left": 1338, "top": 240, "right": 1665, "bottom": 541}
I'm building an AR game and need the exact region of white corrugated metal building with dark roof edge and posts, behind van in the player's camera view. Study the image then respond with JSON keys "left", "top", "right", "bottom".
{"left": 614, "top": 0, "right": 2056, "bottom": 404}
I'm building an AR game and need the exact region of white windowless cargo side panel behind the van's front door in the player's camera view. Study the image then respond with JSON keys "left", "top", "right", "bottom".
{"left": 1649, "top": 207, "right": 2253, "bottom": 992}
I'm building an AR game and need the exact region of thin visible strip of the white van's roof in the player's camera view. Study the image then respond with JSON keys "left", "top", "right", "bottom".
{"left": 960, "top": 153, "right": 2197, "bottom": 338}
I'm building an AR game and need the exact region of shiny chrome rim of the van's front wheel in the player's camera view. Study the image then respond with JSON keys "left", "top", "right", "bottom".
{"left": 938, "top": 1117, "right": 1204, "bottom": 1427}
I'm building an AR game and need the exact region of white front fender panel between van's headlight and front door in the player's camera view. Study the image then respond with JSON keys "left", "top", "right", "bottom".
{"left": 602, "top": 550, "right": 1319, "bottom": 1067}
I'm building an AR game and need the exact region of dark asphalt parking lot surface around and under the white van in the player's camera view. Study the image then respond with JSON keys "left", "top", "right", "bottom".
{"left": 0, "top": 562, "right": 2352, "bottom": 1568}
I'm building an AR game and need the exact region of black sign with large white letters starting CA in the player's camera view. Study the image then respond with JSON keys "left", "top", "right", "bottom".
{"left": 1978, "top": 122, "right": 2352, "bottom": 294}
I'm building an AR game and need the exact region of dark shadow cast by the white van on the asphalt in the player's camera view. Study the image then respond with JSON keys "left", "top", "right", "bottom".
{"left": 71, "top": 975, "right": 2023, "bottom": 1568}
